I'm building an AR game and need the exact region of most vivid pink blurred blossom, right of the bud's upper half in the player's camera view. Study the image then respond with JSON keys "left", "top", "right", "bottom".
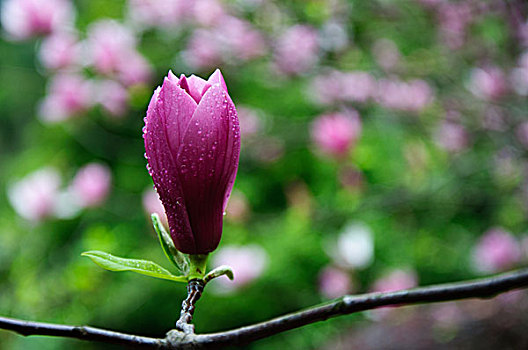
{"left": 311, "top": 110, "right": 361, "bottom": 158}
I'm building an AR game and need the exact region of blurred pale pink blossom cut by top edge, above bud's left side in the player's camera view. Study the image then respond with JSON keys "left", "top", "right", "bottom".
{"left": 128, "top": 0, "right": 192, "bottom": 28}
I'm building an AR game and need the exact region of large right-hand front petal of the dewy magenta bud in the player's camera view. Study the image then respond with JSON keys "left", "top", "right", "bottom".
{"left": 177, "top": 84, "right": 240, "bottom": 253}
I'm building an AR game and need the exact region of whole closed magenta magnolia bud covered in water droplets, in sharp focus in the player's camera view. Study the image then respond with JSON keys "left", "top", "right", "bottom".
{"left": 144, "top": 70, "right": 240, "bottom": 254}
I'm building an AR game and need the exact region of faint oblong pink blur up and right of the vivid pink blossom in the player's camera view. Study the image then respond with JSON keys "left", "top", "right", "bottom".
{"left": 376, "top": 79, "right": 434, "bottom": 112}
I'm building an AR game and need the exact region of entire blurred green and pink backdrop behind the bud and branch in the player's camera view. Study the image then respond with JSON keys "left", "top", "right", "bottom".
{"left": 0, "top": 0, "right": 528, "bottom": 349}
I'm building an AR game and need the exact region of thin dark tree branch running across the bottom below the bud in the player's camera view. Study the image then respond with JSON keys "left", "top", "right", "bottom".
{"left": 0, "top": 269, "right": 528, "bottom": 349}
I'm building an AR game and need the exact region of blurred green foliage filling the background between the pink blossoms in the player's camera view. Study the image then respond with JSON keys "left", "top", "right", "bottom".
{"left": 0, "top": 0, "right": 527, "bottom": 349}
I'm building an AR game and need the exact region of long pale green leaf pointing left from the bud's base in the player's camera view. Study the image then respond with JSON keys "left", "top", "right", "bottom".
{"left": 81, "top": 250, "right": 187, "bottom": 283}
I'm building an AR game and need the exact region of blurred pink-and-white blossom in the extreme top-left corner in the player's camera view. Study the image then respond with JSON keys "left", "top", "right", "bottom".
{"left": 0, "top": 0, "right": 75, "bottom": 40}
